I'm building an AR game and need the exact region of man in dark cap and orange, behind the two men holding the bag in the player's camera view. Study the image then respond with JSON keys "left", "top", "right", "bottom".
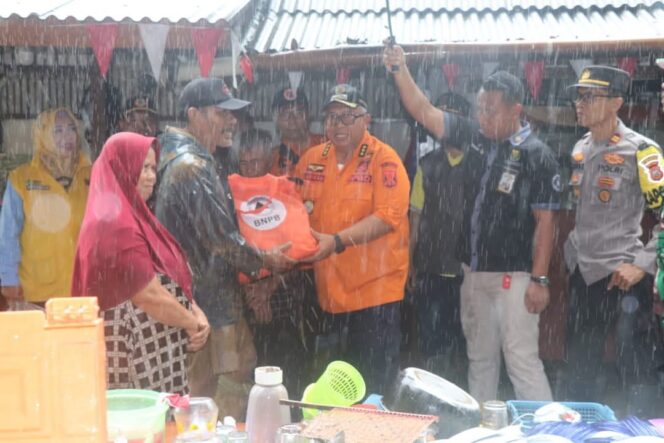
{"left": 271, "top": 88, "right": 323, "bottom": 176}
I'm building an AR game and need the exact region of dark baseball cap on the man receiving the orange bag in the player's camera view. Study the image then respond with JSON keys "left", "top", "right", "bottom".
{"left": 178, "top": 78, "right": 251, "bottom": 112}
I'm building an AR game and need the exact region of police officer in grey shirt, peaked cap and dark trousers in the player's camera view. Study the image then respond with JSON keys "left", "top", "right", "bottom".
{"left": 565, "top": 66, "right": 664, "bottom": 415}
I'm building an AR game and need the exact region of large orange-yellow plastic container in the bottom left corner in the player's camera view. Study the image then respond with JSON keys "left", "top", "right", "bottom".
{"left": 0, "top": 297, "right": 106, "bottom": 443}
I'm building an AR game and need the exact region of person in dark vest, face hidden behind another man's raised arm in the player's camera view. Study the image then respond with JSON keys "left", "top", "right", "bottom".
{"left": 410, "top": 92, "right": 470, "bottom": 386}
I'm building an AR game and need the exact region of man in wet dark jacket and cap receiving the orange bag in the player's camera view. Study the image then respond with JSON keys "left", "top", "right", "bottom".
{"left": 155, "top": 78, "right": 293, "bottom": 418}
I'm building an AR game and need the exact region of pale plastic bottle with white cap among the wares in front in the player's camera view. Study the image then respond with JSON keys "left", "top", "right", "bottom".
{"left": 247, "top": 366, "right": 291, "bottom": 443}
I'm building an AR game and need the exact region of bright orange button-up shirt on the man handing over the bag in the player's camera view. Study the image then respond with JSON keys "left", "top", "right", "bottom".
{"left": 295, "top": 132, "right": 410, "bottom": 313}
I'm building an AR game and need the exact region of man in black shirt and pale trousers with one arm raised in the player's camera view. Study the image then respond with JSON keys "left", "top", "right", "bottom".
{"left": 383, "top": 45, "right": 560, "bottom": 402}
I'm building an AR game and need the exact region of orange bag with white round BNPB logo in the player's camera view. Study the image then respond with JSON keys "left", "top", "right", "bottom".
{"left": 228, "top": 174, "right": 318, "bottom": 283}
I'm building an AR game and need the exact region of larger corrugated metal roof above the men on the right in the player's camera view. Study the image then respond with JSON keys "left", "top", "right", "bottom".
{"left": 246, "top": 0, "right": 664, "bottom": 53}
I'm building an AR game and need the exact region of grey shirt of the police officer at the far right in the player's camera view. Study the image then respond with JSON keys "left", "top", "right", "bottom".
{"left": 565, "top": 121, "right": 664, "bottom": 285}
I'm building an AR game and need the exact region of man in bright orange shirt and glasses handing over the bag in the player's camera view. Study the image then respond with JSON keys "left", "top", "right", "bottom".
{"left": 295, "top": 85, "right": 410, "bottom": 392}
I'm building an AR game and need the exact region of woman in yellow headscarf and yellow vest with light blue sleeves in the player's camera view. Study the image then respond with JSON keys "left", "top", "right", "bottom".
{"left": 0, "top": 108, "right": 90, "bottom": 303}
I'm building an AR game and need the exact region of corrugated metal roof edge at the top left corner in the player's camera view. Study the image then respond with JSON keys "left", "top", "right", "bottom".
{"left": 0, "top": 0, "right": 251, "bottom": 23}
